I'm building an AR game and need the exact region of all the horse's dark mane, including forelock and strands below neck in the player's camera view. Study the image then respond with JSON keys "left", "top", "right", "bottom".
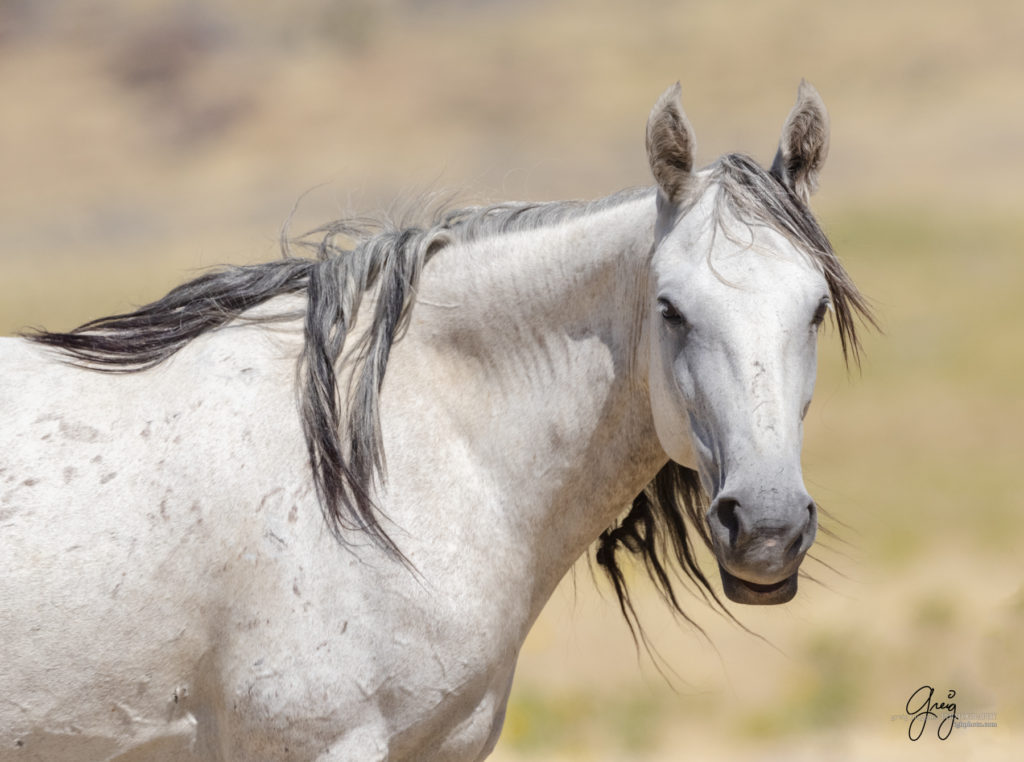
{"left": 28, "top": 155, "right": 870, "bottom": 628}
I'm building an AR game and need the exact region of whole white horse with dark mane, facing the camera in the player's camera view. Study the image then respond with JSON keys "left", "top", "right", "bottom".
{"left": 0, "top": 80, "right": 869, "bottom": 762}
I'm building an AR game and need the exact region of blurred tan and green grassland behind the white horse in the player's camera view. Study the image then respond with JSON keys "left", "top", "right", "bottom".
{"left": 0, "top": 0, "right": 1024, "bottom": 761}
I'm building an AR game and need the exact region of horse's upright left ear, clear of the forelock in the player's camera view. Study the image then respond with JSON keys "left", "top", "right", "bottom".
{"left": 647, "top": 82, "right": 697, "bottom": 204}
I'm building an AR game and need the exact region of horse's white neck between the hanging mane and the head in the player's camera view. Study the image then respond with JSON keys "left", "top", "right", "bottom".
{"left": 414, "top": 191, "right": 665, "bottom": 616}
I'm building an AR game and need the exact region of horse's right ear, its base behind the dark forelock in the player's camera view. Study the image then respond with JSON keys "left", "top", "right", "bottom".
{"left": 771, "top": 80, "right": 828, "bottom": 204}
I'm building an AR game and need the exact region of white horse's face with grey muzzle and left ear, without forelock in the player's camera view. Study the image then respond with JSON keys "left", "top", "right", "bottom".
{"left": 647, "top": 83, "right": 828, "bottom": 603}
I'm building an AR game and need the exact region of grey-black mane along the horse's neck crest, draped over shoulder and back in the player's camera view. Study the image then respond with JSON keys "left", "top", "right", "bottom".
{"left": 25, "top": 188, "right": 652, "bottom": 558}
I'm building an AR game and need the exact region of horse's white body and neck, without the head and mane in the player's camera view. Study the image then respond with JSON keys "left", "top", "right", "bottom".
{"left": 0, "top": 199, "right": 660, "bottom": 759}
